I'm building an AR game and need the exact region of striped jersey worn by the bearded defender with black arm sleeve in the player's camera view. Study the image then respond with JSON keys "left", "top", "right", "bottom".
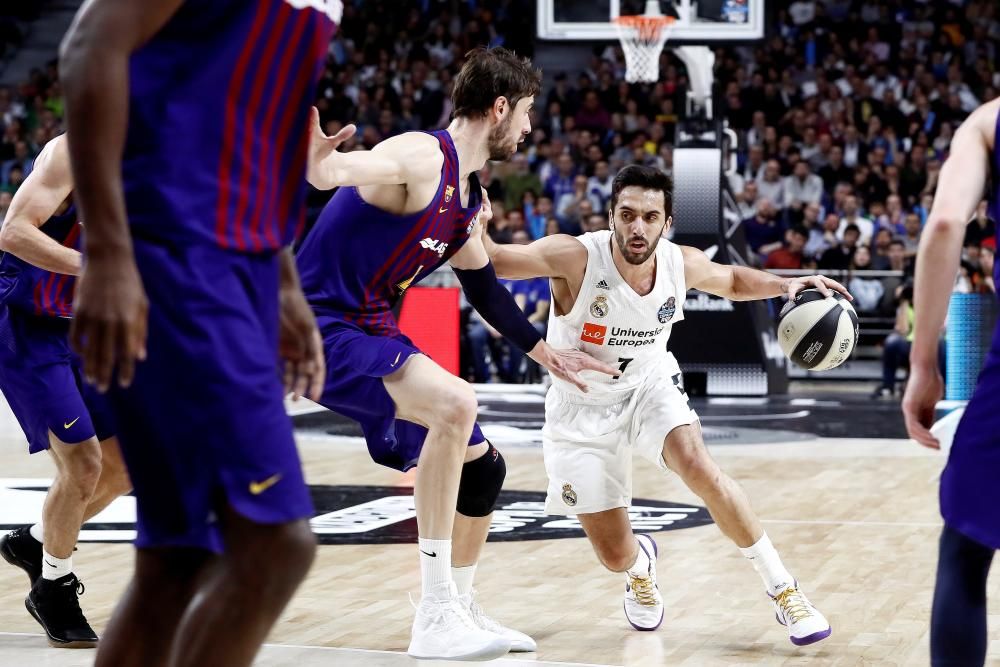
{"left": 297, "top": 130, "right": 482, "bottom": 336}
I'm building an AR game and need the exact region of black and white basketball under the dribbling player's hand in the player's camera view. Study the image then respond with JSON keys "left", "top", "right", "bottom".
{"left": 778, "top": 289, "right": 858, "bottom": 371}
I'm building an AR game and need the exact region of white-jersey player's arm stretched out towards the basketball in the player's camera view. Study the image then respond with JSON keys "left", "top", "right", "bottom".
{"left": 681, "top": 246, "right": 853, "bottom": 301}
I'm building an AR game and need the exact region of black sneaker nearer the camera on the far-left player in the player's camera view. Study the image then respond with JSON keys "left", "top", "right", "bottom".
{"left": 24, "top": 572, "right": 97, "bottom": 648}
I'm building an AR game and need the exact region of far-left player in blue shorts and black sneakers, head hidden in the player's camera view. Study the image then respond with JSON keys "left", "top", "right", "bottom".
{"left": 0, "top": 135, "right": 130, "bottom": 648}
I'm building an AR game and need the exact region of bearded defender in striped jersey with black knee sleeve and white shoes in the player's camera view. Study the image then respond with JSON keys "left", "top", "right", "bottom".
{"left": 298, "top": 48, "right": 614, "bottom": 660}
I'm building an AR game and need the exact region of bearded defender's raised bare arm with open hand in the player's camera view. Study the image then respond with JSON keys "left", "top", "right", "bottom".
{"left": 306, "top": 107, "right": 441, "bottom": 190}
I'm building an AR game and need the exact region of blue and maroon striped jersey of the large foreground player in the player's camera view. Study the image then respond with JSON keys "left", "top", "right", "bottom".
{"left": 123, "top": 0, "right": 343, "bottom": 253}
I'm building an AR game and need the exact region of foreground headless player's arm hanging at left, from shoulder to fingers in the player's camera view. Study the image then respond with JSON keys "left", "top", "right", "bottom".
{"left": 59, "top": 0, "right": 183, "bottom": 391}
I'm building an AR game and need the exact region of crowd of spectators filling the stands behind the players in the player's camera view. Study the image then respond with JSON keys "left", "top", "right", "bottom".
{"left": 0, "top": 0, "right": 1000, "bottom": 380}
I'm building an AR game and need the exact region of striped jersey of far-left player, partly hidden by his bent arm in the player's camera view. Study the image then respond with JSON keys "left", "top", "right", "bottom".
{"left": 0, "top": 206, "right": 83, "bottom": 317}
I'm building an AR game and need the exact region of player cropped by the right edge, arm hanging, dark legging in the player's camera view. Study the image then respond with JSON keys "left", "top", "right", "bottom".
{"left": 903, "top": 100, "right": 1000, "bottom": 667}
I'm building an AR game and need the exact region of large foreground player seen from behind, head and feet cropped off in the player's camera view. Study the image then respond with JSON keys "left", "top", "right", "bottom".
{"left": 59, "top": 0, "right": 343, "bottom": 667}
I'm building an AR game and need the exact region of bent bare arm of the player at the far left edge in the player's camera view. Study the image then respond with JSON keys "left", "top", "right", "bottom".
{"left": 0, "top": 134, "right": 80, "bottom": 275}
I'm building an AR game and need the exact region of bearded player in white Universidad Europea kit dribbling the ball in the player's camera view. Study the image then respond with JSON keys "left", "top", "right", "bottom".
{"left": 487, "top": 166, "right": 849, "bottom": 645}
